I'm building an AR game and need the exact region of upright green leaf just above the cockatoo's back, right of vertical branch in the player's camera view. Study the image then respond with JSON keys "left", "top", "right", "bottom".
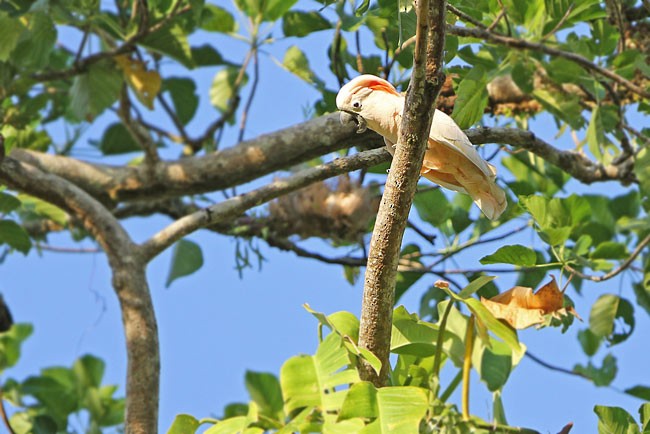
{"left": 451, "top": 66, "right": 489, "bottom": 129}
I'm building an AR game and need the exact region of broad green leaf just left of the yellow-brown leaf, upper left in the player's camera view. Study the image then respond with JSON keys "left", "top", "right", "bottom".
{"left": 70, "top": 62, "right": 123, "bottom": 120}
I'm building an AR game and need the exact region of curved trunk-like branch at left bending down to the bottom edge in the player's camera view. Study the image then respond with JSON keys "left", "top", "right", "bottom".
{"left": 0, "top": 157, "right": 160, "bottom": 434}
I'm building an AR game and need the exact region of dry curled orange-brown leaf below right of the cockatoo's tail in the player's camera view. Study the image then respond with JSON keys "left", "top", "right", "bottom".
{"left": 481, "top": 277, "right": 582, "bottom": 329}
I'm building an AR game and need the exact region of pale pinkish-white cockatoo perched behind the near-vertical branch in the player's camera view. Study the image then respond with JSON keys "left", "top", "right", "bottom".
{"left": 336, "top": 74, "right": 507, "bottom": 220}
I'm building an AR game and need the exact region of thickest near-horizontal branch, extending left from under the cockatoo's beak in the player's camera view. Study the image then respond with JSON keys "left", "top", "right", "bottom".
{"left": 12, "top": 114, "right": 374, "bottom": 203}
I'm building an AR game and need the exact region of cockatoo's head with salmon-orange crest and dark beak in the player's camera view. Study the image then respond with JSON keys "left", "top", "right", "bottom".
{"left": 336, "top": 74, "right": 400, "bottom": 134}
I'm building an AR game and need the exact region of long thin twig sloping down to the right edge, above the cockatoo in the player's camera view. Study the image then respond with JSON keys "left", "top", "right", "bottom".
{"left": 447, "top": 26, "right": 650, "bottom": 98}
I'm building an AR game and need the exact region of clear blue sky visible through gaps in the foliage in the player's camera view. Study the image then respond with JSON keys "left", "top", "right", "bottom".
{"left": 0, "top": 1, "right": 650, "bottom": 433}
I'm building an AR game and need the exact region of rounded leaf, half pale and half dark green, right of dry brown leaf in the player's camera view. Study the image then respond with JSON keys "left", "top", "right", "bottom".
{"left": 589, "top": 294, "right": 635, "bottom": 344}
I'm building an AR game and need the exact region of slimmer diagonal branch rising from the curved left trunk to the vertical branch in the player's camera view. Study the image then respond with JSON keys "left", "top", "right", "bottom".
{"left": 142, "top": 149, "right": 389, "bottom": 261}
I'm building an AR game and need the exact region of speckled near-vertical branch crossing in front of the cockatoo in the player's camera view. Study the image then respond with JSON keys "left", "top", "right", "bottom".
{"left": 359, "top": 0, "right": 446, "bottom": 387}
